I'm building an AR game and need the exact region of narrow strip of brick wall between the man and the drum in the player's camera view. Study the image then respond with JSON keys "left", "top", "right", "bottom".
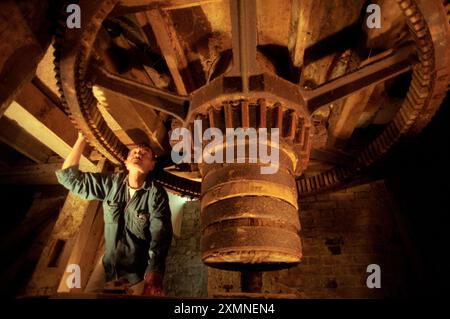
{"left": 164, "top": 201, "right": 208, "bottom": 298}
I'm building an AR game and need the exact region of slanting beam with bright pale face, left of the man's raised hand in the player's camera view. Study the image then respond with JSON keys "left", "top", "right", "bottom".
{"left": 5, "top": 84, "right": 95, "bottom": 170}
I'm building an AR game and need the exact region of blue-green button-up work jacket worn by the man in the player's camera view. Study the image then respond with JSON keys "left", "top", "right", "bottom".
{"left": 56, "top": 166, "right": 172, "bottom": 284}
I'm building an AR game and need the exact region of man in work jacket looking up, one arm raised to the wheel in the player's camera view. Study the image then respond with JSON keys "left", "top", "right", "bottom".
{"left": 56, "top": 133, "right": 172, "bottom": 295}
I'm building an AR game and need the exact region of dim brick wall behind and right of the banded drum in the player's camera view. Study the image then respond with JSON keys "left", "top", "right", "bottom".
{"left": 208, "top": 181, "right": 410, "bottom": 298}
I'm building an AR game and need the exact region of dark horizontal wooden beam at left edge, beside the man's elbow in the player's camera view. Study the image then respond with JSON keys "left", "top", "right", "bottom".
{"left": 0, "top": 163, "right": 62, "bottom": 185}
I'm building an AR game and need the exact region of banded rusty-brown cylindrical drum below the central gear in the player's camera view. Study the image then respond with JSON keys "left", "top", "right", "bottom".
{"left": 201, "top": 144, "right": 302, "bottom": 270}
